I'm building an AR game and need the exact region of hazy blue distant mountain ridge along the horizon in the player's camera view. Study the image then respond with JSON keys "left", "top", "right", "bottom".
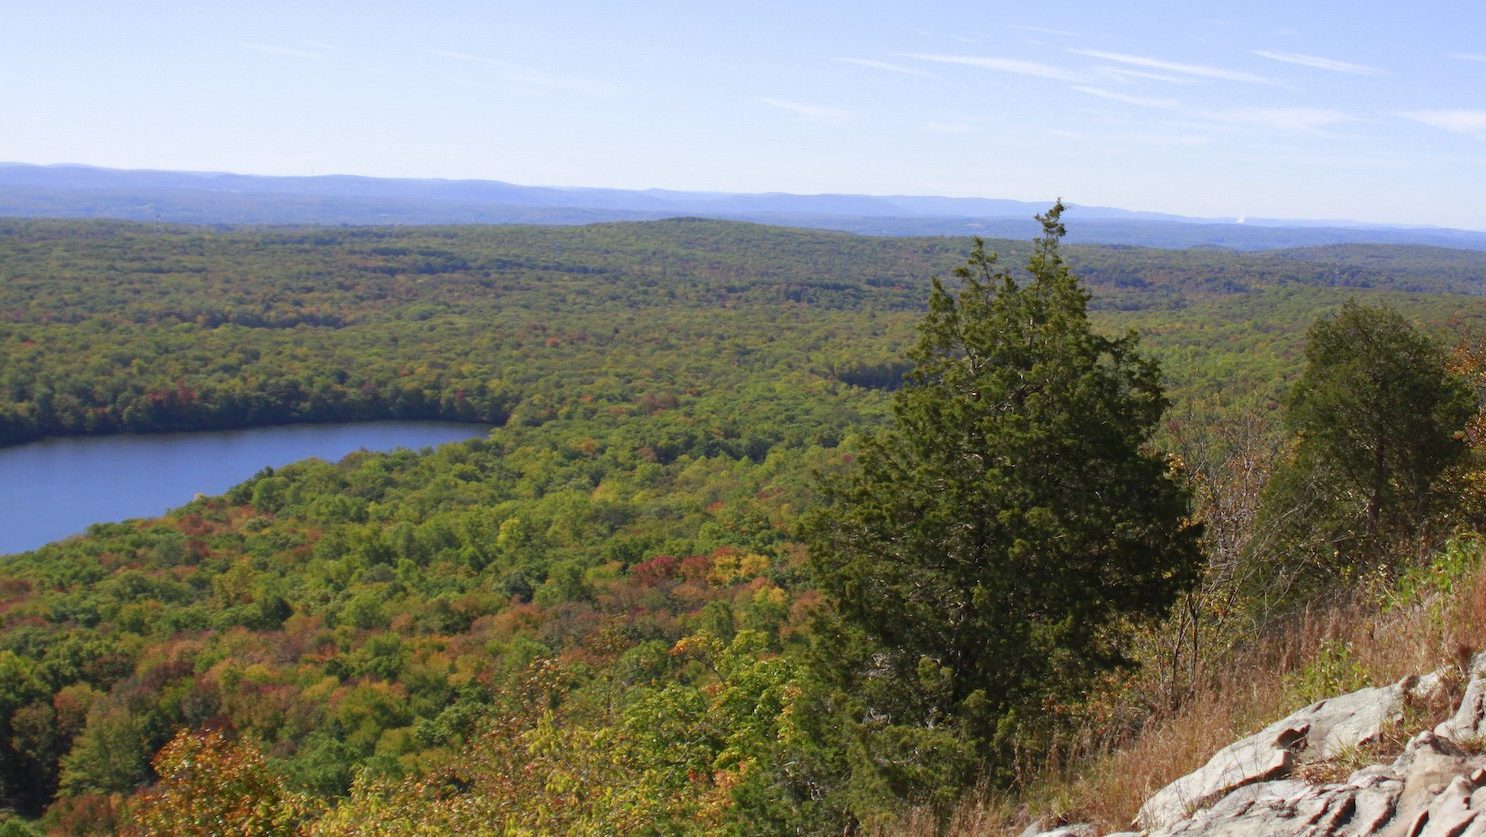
{"left": 0, "top": 164, "right": 1486, "bottom": 250}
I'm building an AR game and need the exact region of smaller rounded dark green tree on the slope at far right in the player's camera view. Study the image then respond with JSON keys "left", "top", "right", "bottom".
{"left": 1259, "top": 302, "right": 1474, "bottom": 601}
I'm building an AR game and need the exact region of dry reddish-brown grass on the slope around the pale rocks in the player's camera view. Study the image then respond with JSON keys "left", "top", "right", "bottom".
{"left": 871, "top": 553, "right": 1486, "bottom": 836}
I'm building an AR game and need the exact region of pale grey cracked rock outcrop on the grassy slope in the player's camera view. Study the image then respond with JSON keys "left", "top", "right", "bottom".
{"left": 1045, "top": 654, "right": 1486, "bottom": 837}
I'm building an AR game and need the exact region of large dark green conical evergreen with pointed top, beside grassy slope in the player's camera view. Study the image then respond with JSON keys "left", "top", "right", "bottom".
{"left": 805, "top": 204, "right": 1201, "bottom": 804}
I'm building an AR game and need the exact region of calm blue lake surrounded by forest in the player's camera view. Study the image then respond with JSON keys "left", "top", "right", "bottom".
{"left": 0, "top": 421, "right": 490, "bottom": 555}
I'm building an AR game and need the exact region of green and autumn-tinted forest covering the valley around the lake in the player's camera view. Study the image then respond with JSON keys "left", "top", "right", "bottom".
{"left": 0, "top": 220, "right": 1486, "bottom": 833}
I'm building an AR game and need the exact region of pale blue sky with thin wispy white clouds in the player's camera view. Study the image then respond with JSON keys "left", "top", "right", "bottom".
{"left": 0, "top": 0, "right": 1486, "bottom": 229}
